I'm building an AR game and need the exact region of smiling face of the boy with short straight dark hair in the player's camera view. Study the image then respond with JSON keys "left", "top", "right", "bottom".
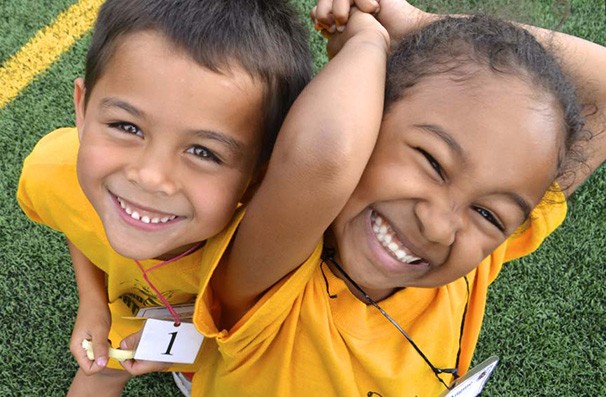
{"left": 74, "top": 32, "right": 263, "bottom": 259}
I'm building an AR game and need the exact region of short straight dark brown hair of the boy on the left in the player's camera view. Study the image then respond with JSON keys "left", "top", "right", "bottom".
{"left": 84, "top": 0, "right": 312, "bottom": 164}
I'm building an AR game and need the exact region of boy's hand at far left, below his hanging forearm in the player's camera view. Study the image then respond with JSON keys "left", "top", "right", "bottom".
{"left": 69, "top": 302, "right": 111, "bottom": 375}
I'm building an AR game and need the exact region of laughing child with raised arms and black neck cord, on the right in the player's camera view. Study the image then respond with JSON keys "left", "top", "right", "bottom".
{"left": 185, "top": 2, "right": 604, "bottom": 396}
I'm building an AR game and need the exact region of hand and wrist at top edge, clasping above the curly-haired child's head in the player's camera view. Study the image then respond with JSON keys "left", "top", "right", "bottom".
{"left": 312, "top": 0, "right": 437, "bottom": 40}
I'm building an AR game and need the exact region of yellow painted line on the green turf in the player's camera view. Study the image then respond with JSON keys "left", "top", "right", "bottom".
{"left": 0, "top": 0, "right": 104, "bottom": 109}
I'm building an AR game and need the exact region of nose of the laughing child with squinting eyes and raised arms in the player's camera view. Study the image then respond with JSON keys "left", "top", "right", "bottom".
{"left": 415, "top": 199, "right": 464, "bottom": 245}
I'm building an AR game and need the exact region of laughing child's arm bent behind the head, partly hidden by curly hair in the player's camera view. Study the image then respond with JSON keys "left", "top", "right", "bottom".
{"left": 313, "top": 0, "right": 606, "bottom": 196}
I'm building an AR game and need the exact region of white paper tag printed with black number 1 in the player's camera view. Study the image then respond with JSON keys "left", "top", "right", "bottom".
{"left": 135, "top": 319, "right": 204, "bottom": 364}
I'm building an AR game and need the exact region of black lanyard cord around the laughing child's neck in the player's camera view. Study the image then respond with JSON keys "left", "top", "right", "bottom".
{"left": 322, "top": 249, "right": 469, "bottom": 390}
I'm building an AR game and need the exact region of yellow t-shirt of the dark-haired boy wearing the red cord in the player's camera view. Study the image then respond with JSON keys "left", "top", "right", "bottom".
{"left": 17, "top": 128, "right": 207, "bottom": 371}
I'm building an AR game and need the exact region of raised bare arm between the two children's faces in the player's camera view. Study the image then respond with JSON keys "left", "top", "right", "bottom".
{"left": 212, "top": 12, "right": 389, "bottom": 328}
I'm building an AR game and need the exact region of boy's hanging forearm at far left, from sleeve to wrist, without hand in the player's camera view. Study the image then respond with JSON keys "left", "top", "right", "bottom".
{"left": 67, "top": 240, "right": 108, "bottom": 305}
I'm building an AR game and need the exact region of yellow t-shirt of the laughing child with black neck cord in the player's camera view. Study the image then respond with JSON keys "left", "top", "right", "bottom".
{"left": 192, "top": 190, "right": 566, "bottom": 397}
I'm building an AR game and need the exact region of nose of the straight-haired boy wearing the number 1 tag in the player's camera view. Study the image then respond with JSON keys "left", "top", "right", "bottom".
{"left": 126, "top": 149, "right": 178, "bottom": 196}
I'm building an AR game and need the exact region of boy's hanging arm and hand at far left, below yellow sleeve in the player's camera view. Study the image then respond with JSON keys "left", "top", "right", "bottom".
{"left": 67, "top": 240, "right": 111, "bottom": 375}
